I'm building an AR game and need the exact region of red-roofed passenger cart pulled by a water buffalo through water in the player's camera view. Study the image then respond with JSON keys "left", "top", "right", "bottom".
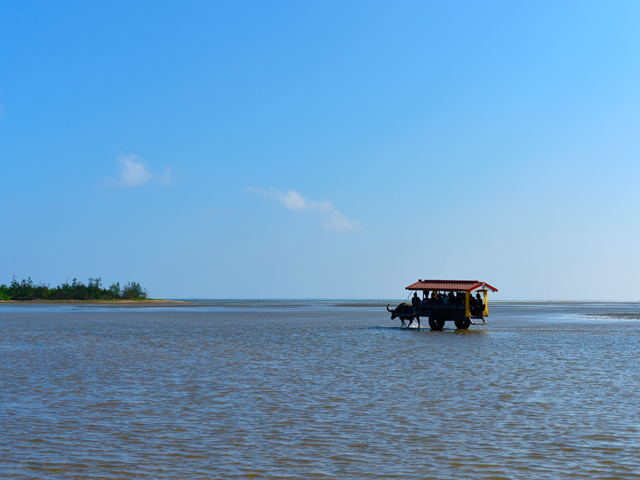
{"left": 387, "top": 280, "right": 498, "bottom": 330}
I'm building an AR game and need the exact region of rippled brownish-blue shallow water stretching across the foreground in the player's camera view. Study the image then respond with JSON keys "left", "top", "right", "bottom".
{"left": 0, "top": 302, "right": 640, "bottom": 479}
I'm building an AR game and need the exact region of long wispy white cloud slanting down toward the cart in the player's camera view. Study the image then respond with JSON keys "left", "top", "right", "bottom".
{"left": 245, "top": 187, "right": 360, "bottom": 232}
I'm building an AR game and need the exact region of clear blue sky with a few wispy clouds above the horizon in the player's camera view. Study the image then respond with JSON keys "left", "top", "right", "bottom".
{"left": 0, "top": 1, "right": 640, "bottom": 301}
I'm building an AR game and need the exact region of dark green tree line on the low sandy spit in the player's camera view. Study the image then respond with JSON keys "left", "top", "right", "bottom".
{"left": 0, "top": 275, "right": 148, "bottom": 300}
